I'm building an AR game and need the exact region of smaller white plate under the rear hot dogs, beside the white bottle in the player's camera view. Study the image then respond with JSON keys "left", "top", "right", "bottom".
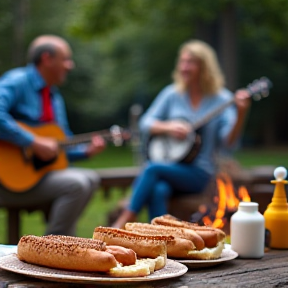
{"left": 177, "top": 244, "right": 238, "bottom": 268}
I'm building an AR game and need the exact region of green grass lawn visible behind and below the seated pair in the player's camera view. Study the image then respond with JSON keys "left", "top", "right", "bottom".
{"left": 0, "top": 146, "right": 288, "bottom": 243}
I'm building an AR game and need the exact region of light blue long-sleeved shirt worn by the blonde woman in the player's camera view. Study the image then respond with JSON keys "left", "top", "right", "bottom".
{"left": 139, "top": 85, "right": 239, "bottom": 174}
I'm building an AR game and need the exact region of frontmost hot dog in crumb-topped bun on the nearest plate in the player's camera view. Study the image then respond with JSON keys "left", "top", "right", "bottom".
{"left": 17, "top": 235, "right": 166, "bottom": 277}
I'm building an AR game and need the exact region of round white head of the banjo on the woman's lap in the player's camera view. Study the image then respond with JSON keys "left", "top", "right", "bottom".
{"left": 147, "top": 133, "right": 196, "bottom": 163}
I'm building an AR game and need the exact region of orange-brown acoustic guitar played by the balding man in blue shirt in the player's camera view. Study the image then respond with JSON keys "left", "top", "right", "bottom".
{"left": 0, "top": 123, "right": 129, "bottom": 192}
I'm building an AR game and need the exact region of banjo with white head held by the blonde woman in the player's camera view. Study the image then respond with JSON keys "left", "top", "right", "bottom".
{"left": 147, "top": 77, "right": 272, "bottom": 163}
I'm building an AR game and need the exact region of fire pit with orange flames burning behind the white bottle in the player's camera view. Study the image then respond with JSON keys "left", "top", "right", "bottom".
{"left": 169, "top": 166, "right": 275, "bottom": 234}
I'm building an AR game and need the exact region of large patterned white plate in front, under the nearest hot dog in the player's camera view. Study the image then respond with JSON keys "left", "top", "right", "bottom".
{"left": 0, "top": 254, "right": 188, "bottom": 284}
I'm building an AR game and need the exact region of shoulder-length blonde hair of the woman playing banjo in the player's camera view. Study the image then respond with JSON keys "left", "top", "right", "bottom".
{"left": 173, "top": 40, "right": 225, "bottom": 95}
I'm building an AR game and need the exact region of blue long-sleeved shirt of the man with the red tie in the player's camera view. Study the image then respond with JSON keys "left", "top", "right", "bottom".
{"left": 0, "top": 64, "right": 86, "bottom": 161}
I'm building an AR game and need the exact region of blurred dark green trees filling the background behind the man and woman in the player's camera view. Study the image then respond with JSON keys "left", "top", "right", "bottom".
{"left": 0, "top": 0, "right": 288, "bottom": 148}
